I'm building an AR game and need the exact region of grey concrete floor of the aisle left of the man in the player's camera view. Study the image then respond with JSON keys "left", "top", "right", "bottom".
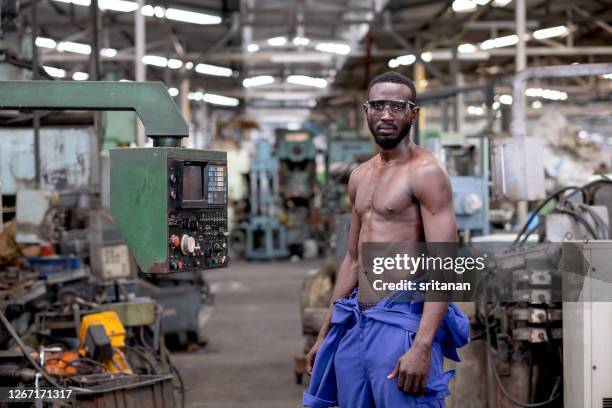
{"left": 173, "top": 260, "right": 322, "bottom": 408}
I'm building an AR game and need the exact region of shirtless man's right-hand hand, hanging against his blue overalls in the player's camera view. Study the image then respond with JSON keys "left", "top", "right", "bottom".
{"left": 387, "top": 344, "right": 431, "bottom": 396}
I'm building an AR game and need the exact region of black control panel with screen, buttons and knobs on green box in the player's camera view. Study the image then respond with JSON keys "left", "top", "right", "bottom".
{"left": 168, "top": 159, "right": 229, "bottom": 271}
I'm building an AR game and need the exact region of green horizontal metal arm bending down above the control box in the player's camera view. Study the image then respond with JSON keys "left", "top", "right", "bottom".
{"left": 0, "top": 81, "right": 189, "bottom": 146}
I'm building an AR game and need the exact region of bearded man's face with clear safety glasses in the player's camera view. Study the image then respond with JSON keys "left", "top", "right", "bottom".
{"left": 364, "top": 82, "right": 418, "bottom": 149}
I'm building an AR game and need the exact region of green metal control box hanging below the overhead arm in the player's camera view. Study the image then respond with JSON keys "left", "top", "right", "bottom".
{"left": 110, "top": 147, "right": 229, "bottom": 273}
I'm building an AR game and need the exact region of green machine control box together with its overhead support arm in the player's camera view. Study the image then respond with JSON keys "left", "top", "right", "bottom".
{"left": 0, "top": 81, "right": 229, "bottom": 273}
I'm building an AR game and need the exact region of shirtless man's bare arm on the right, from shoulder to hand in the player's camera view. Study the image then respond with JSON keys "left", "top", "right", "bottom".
{"left": 387, "top": 162, "right": 457, "bottom": 395}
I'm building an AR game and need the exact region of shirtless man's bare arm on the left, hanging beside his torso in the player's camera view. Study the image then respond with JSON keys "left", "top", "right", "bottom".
{"left": 306, "top": 169, "right": 361, "bottom": 374}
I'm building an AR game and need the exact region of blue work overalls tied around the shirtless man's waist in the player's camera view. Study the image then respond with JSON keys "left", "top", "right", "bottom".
{"left": 303, "top": 290, "right": 470, "bottom": 408}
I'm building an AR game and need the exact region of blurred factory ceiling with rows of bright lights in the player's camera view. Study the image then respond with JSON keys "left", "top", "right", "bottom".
{"left": 20, "top": 0, "right": 612, "bottom": 118}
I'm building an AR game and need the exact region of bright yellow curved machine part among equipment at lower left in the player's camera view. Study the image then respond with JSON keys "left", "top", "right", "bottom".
{"left": 79, "top": 311, "right": 132, "bottom": 374}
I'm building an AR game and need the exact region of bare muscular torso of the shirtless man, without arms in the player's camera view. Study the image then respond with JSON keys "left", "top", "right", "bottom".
{"left": 349, "top": 145, "right": 437, "bottom": 303}
